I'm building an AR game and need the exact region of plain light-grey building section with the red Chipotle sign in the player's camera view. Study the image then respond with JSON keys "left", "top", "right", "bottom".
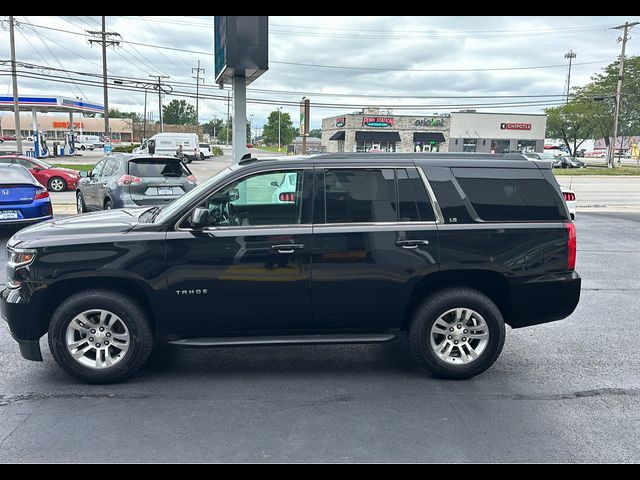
{"left": 449, "top": 110, "right": 547, "bottom": 153}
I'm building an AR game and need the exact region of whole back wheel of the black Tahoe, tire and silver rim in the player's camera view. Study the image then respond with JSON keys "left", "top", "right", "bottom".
{"left": 409, "top": 287, "right": 505, "bottom": 379}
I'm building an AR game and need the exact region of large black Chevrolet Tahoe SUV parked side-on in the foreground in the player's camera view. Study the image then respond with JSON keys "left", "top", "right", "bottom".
{"left": 1, "top": 153, "right": 580, "bottom": 383}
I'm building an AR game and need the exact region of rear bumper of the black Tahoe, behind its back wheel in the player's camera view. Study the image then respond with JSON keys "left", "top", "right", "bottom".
{"left": 508, "top": 272, "right": 582, "bottom": 328}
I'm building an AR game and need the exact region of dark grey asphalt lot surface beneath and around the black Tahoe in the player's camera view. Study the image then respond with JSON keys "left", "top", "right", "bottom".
{"left": 0, "top": 212, "right": 640, "bottom": 463}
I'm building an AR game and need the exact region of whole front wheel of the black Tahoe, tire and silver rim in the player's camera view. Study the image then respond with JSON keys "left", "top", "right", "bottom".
{"left": 49, "top": 290, "right": 153, "bottom": 383}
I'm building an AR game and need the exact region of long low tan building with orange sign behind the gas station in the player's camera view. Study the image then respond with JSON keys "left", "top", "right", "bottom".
{"left": 0, "top": 113, "right": 133, "bottom": 143}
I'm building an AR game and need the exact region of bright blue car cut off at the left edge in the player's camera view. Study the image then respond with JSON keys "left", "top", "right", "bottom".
{"left": 0, "top": 164, "right": 53, "bottom": 225}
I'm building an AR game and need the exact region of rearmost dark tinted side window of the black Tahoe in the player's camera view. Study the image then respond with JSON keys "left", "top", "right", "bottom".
{"left": 453, "top": 169, "right": 564, "bottom": 221}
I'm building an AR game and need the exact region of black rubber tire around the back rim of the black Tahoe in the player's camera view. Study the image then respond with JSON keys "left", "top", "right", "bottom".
{"left": 408, "top": 287, "right": 505, "bottom": 380}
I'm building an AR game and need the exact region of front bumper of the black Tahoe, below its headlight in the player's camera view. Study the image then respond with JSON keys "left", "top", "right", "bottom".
{"left": 0, "top": 288, "right": 46, "bottom": 362}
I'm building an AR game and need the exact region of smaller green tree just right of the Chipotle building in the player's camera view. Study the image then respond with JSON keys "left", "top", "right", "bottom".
{"left": 545, "top": 102, "right": 594, "bottom": 155}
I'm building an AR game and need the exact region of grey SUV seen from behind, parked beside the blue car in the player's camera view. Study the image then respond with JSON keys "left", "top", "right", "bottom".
{"left": 76, "top": 153, "right": 197, "bottom": 213}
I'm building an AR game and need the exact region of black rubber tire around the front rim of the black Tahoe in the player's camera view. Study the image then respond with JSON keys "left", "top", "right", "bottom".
{"left": 49, "top": 289, "right": 153, "bottom": 383}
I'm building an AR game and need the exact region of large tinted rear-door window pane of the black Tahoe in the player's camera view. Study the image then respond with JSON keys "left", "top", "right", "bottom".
{"left": 324, "top": 168, "right": 398, "bottom": 223}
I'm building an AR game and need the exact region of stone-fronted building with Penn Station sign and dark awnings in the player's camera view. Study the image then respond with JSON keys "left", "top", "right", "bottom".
{"left": 322, "top": 108, "right": 450, "bottom": 152}
